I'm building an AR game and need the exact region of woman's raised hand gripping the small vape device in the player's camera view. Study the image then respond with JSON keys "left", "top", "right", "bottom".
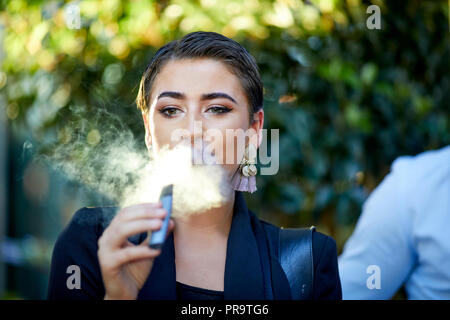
{"left": 97, "top": 202, "right": 174, "bottom": 300}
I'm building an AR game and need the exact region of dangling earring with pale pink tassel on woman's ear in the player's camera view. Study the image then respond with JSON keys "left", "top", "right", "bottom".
{"left": 231, "top": 144, "right": 257, "bottom": 193}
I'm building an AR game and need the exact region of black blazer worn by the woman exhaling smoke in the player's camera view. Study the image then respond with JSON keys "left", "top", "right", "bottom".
{"left": 48, "top": 191, "right": 342, "bottom": 300}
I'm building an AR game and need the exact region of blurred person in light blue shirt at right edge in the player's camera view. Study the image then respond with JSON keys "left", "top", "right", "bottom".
{"left": 338, "top": 146, "right": 450, "bottom": 300}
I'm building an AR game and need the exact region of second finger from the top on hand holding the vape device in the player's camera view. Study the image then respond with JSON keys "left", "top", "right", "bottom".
{"left": 110, "top": 219, "right": 163, "bottom": 248}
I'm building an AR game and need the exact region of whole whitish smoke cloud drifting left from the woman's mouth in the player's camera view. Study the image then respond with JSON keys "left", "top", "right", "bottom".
{"left": 37, "top": 106, "right": 232, "bottom": 217}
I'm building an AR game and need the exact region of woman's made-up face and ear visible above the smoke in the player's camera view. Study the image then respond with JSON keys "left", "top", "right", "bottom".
{"left": 143, "top": 58, "right": 264, "bottom": 178}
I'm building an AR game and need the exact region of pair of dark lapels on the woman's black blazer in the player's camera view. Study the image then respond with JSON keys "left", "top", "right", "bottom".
{"left": 138, "top": 191, "right": 289, "bottom": 300}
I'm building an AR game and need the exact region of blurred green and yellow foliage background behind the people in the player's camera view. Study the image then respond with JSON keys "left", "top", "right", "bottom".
{"left": 0, "top": 0, "right": 450, "bottom": 299}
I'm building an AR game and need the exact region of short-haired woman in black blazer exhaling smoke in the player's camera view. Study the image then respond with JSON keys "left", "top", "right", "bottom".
{"left": 48, "top": 32, "right": 341, "bottom": 300}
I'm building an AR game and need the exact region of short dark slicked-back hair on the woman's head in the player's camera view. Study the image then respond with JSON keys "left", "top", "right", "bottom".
{"left": 136, "top": 31, "right": 263, "bottom": 122}
